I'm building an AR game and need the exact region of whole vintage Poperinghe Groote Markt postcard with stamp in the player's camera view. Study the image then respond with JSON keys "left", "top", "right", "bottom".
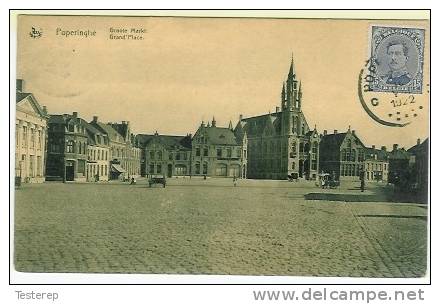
{"left": 10, "top": 15, "right": 430, "bottom": 278}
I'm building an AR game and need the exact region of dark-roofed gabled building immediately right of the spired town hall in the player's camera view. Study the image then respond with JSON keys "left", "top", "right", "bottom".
{"left": 319, "top": 128, "right": 365, "bottom": 180}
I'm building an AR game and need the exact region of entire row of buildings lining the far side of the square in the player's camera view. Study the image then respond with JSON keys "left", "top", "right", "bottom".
{"left": 15, "top": 60, "right": 429, "bottom": 189}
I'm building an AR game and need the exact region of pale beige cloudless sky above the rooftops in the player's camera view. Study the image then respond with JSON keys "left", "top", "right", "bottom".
{"left": 17, "top": 16, "right": 430, "bottom": 148}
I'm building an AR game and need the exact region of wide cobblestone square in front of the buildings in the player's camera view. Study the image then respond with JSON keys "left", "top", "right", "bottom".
{"left": 14, "top": 179, "right": 427, "bottom": 277}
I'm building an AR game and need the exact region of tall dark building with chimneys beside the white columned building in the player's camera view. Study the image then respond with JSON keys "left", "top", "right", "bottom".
{"left": 46, "top": 112, "right": 88, "bottom": 181}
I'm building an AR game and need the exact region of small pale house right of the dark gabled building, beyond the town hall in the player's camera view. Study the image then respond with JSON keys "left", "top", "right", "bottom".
{"left": 364, "top": 145, "right": 389, "bottom": 182}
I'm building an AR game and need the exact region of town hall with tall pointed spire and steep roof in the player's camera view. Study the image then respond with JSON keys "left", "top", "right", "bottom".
{"left": 235, "top": 59, "right": 320, "bottom": 179}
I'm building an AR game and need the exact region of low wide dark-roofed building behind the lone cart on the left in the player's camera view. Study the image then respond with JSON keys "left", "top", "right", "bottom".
{"left": 136, "top": 132, "right": 191, "bottom": 177}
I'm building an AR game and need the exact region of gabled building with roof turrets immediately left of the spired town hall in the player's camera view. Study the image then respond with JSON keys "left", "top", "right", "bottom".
{"left": 191, "top": 118, "right": 247, "bottom": 178}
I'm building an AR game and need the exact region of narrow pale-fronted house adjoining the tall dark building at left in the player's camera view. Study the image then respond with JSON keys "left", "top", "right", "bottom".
{"left": 86, "top": 124, "right": 110, "bottom": 182}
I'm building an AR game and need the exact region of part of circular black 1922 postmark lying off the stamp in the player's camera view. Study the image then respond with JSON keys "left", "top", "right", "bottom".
{"left": 358, "top": 59, "right": 426, "bottom": 127}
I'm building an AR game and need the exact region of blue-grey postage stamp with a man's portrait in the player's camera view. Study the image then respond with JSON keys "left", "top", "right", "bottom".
{"left": 370, "top": 26, "right": 425, "bottom": 94}
